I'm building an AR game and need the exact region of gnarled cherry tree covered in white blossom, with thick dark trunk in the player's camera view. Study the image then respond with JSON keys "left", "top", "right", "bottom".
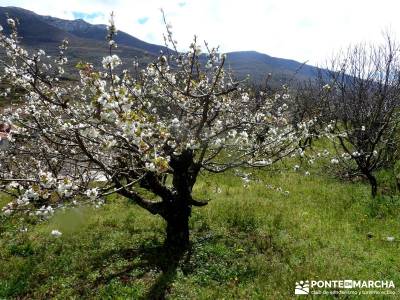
{"left": 0, "top": 18, "right": 307, "bottom": 247}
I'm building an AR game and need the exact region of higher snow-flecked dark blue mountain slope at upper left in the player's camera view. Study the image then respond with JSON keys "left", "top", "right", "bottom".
{"left": 0, "top": 7, "right": 159, "bottom": 72}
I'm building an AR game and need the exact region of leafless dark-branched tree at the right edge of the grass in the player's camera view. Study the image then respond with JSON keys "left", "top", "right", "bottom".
{"left": 320, "top": 35, "right": 400, "bottom": 197}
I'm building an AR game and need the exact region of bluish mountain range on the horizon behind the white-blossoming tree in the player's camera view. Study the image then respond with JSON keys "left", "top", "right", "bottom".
{"left": 0, "top": 7, "right": 318, "bottom": 84}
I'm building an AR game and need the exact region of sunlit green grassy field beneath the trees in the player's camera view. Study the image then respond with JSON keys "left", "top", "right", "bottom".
{"left": 0, "top": 159, "right": 400, "bottom": 299}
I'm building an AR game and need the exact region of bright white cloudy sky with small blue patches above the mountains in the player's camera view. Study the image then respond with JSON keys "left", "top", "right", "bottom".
{"left": 0, "top": 0, "right": 400, "bottom": 65}
